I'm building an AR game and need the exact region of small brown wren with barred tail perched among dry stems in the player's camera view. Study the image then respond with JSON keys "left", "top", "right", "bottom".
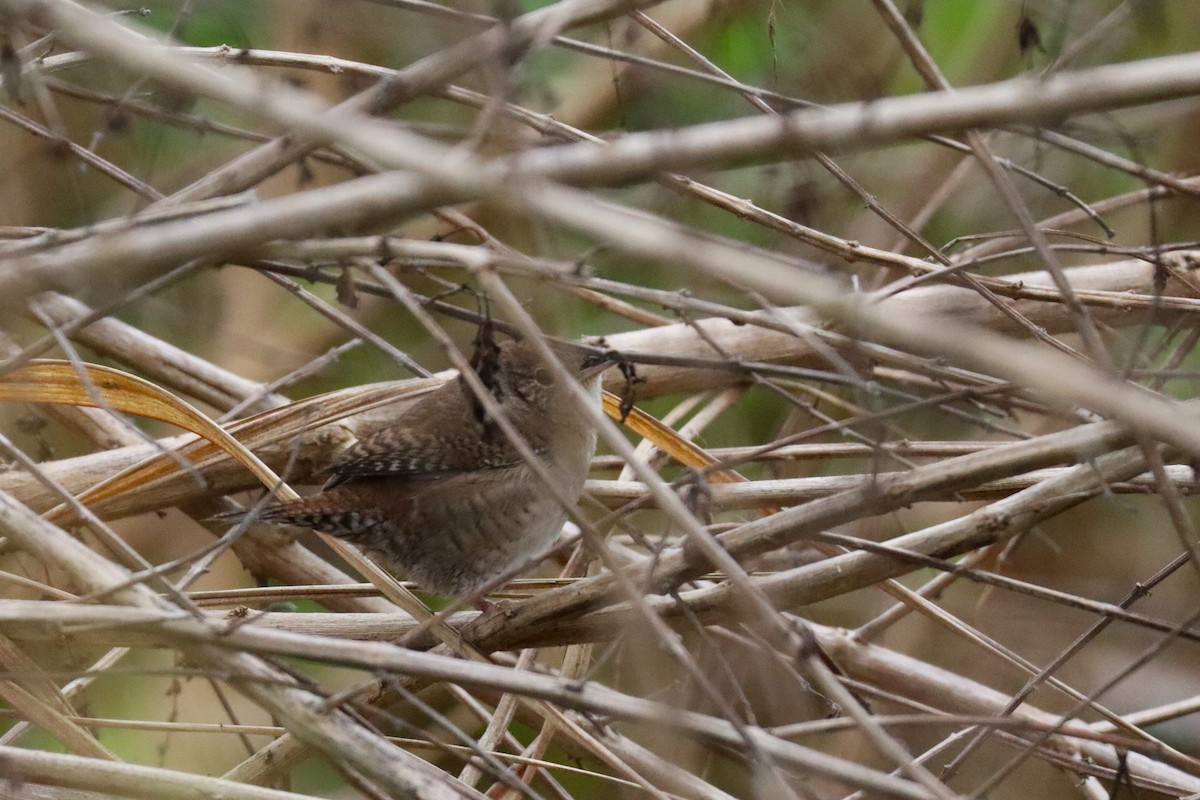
{"left": 230, "top": 341, "right": 612, "bottom": 596}
